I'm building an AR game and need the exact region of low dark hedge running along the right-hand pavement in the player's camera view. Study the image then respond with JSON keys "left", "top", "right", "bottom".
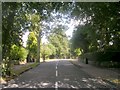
{"left": 80, "top": 51, "right": 120, "bottom": 68}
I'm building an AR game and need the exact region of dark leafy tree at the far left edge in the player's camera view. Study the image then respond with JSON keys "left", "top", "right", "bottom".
{"left": 2, "top": 2, "right": 26, "bottom": 76}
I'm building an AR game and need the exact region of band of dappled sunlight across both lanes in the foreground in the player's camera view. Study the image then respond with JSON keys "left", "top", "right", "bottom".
{"left": 4, "top": 78, "right": 114, "bottom": 89}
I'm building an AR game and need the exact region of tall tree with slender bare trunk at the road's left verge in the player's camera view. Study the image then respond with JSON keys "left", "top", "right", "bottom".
{"left": 24, "top": 2, "right": 71, "bottom": 62}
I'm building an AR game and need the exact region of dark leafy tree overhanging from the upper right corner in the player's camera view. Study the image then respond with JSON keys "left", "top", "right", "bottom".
{"left": 71, "top": 2, "right": 120, "bottom": 51}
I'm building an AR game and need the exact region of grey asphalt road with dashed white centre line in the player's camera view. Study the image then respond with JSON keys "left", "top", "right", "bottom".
{"left": 2, "top": 60, "right": 116, "bottom": 90}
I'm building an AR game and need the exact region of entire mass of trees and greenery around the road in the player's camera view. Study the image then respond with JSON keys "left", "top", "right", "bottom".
{"left": 0, "top": 2, "right": 120, "bottom": 77}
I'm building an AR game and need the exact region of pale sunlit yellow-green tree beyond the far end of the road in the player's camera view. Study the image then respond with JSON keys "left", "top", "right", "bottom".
{"left": 48, "top": 27, "right": 69, "bottom": 58}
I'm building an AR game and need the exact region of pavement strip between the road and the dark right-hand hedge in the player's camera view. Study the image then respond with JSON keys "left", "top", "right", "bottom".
{"left": 70, "top": 59, "right": 120, "bottom": 87}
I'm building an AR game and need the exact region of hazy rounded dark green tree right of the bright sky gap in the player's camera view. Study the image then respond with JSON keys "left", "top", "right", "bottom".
{"left": 71, "top": 26, "right": 90, "bottom": 53}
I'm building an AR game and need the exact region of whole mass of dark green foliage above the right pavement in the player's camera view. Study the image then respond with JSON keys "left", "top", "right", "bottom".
{"left": 71, "top": 2, "right": 120, "bottom": 62}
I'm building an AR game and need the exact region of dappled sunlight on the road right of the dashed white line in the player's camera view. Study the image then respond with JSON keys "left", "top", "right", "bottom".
{"left": 55, "top": 78, "right": 114, "bottom": 89}
